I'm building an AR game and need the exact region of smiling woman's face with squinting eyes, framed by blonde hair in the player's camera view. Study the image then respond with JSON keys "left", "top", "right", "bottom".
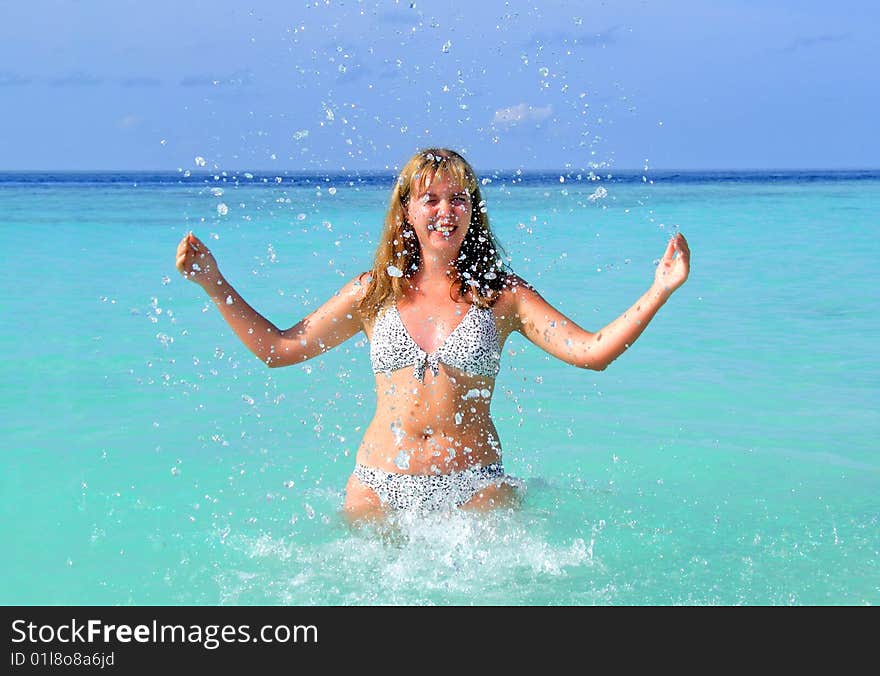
{"left": 406, "top": 178, "right": 473, "bottom": 262}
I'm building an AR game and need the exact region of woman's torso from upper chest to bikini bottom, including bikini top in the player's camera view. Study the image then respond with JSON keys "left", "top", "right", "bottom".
{"left": 357, "top": 292, "right": 510, "bottom": 474}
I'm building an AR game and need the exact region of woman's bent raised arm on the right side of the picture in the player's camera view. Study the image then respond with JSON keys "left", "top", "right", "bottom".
{"left": 512, "top": 233, "right": 690, "bottom": 371}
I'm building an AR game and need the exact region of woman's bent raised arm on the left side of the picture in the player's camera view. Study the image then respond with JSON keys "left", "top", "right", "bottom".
{"left": 177, "top": 233, "right": 364, "bottom": 367}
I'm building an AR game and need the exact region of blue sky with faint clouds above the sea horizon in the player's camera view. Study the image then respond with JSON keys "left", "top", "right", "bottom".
{"left": 0, "top": 0, "right": 880, "bottom": 171}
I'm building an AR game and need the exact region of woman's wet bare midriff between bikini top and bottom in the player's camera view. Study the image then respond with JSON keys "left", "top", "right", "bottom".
{"left": 357, "top": 363, "right": 501, "bottom": 474}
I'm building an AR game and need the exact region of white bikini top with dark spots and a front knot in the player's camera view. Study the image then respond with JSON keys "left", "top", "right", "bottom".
{"left": 370, "top": 303, "right": 501, "bottom": 382}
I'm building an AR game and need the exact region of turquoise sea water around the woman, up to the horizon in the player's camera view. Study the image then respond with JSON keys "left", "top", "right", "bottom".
{"left": 0, "top": 173, "right": 880, "bottom": 605}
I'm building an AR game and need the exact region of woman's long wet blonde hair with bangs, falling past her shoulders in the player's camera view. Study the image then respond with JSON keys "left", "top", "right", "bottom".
{"left": 359, "top": 148, "right": 507, "bottom": 320}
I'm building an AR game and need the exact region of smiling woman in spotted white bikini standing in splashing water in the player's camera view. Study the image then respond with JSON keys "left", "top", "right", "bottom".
{"left": 177, "top": 148, "right": 690, "bottom": 520}
